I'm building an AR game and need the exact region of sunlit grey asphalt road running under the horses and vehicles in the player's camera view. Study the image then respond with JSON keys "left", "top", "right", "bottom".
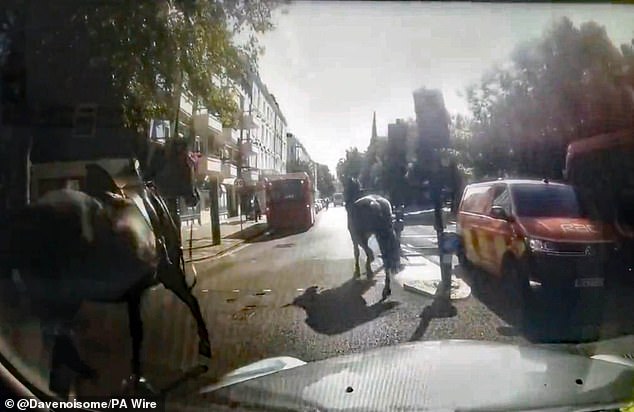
{"left": 0, "top": 207, "right": 634, "bottom": 397}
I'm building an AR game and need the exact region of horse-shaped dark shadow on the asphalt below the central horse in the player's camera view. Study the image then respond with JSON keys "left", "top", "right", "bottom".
{"left": 287, "top": 279, "right": 398, "bottom": 335}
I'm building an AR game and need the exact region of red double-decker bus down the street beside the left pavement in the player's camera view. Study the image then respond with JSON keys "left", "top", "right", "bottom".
{"left": 266, "top": 173, "right": 315, "bottom": 229}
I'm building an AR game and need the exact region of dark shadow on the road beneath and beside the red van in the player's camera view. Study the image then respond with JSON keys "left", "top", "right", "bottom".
{"left": 457, "top": 268, "right": 634, "bottom": 343}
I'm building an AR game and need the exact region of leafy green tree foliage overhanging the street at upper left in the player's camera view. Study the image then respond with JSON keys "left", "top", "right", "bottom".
{"left": 0, "top": 0, "right": 282, "bottom": 131}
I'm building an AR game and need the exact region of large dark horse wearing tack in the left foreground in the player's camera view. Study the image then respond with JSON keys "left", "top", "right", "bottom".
{"left": 1, "top": 141, "right": 211, "bottom": 396}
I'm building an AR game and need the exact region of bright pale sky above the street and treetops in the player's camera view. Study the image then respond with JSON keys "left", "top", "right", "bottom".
{"left": 254, "top": 1, "right": 634, "bottom": 172}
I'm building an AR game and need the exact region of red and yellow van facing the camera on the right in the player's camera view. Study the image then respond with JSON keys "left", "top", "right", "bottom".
{"left": 457, "top": 180, "right": 618, "bottom": 298}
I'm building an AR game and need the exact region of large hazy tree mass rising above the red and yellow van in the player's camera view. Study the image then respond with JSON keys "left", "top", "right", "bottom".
{"left": 467, "top": 18, "right": 634, "bottom": 178}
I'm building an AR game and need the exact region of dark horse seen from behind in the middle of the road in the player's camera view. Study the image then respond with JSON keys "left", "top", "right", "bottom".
{"left": 344, "top": 178, "right": 401, "bottom": 299}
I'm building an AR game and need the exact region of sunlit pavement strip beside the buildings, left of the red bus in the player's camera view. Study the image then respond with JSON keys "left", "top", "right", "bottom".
{"left": 181, "top": 216, "right": 268, "bottom": 263}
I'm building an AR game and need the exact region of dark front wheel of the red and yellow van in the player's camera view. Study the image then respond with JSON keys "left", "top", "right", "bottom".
{"left": 502, "top": 259, "right": 535, "bottom": 329}
